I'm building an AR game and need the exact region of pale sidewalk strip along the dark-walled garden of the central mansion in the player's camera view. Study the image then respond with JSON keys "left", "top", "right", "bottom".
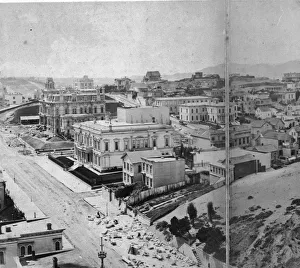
{"left": 34, "top": 156, "right": 91, "bottom": 193}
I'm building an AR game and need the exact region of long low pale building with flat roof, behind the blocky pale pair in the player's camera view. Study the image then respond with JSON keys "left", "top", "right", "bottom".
{"left": 153, "top": 96, "right": 212, "bottom": 114}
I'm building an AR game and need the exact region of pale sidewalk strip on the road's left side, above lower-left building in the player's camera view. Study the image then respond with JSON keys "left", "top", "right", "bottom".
{"left": 3, "top": 171, "right": 47, "bottom": 221}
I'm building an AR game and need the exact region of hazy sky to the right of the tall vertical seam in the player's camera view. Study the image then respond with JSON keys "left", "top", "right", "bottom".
{"left": 230, "top": 0, "right": 300, "bottom": 64}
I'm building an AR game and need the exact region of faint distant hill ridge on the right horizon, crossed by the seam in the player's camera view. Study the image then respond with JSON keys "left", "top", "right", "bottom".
{"left": 201, "top": 60, "right": 300, "bottom": 79}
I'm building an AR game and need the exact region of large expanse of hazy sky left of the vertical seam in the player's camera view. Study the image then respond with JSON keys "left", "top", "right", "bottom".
{"left": 0, "top": 0, "right": 224, "bottom": 77}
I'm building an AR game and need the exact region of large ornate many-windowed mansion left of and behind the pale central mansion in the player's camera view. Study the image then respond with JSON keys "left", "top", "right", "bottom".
{"left": 39, "top": 87, "right": 105, "bottom": 136}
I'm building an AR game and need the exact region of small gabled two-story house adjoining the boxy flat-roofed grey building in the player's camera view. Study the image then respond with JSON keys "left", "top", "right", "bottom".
{"left": 122, "top": 148, "right": 173, "bottom": 184}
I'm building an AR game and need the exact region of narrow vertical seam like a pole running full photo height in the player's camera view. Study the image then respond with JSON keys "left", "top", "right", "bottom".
{"left": 224, "top": 0, "right": 231, "bottom": 268}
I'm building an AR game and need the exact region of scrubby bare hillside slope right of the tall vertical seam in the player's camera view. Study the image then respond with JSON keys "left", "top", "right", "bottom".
{"left": 230, "top": 163, "right": 300, "bottom": 268}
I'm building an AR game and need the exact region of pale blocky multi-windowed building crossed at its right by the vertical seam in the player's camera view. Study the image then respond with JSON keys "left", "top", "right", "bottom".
{"left": 179, "top": 101, "right": 238, "bottom": 124}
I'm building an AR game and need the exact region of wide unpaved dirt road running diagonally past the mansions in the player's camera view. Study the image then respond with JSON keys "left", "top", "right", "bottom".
{"left": 0, "top": 132, "right": 125, "bottom": 268}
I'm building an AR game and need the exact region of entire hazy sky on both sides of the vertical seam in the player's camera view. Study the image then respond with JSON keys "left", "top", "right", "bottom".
{"left": 0, "top": 0, "right": 300, "bottom": 77}
